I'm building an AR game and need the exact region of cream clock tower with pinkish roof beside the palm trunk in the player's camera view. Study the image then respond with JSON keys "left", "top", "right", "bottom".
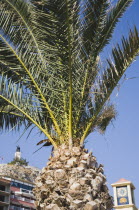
{"left": 111, "top": 179, "right": 138, "bottom": 210}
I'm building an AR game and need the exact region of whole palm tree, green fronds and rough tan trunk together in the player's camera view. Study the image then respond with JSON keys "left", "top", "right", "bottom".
{"left": 0, "top": 0, "right": 139, "bottom": 210}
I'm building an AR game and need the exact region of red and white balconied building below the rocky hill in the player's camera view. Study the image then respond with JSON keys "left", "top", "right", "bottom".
{"left": 0, "top": 177, "right": 35, "bottom": 210}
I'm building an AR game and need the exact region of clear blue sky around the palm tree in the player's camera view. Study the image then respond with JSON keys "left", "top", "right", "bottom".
{"left": 0, "top": 0, "right": 139, "bottom": 208}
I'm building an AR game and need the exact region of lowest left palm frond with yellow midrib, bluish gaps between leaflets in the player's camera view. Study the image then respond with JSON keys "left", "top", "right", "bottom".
{"left": 0, "top": 76, "right": 55, "bottom": 145}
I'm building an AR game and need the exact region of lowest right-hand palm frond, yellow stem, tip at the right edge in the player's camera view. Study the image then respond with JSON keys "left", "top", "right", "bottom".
{"left": 81, "top": 27, "right": 139, "bottom": 142}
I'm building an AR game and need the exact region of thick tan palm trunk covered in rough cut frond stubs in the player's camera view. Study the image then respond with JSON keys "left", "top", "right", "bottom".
{"left": 34, "top": 145, "right": 113, "bottom": 210}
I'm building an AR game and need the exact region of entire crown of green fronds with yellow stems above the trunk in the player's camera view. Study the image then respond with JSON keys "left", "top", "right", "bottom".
{"left": 0, "top": 0, "right": 139, "bottom": 147}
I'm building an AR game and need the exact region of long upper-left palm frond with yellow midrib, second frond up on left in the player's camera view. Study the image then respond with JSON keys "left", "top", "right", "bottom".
{"left": 0, "top": 8, "right": 61, "bottom": 138}
